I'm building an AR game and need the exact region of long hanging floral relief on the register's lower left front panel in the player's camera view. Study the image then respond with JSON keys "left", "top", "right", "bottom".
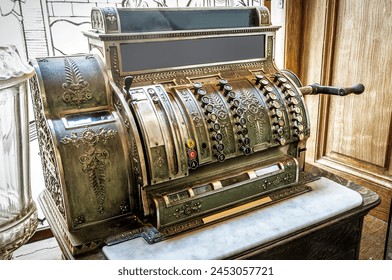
{"left": 61, "top": 128, "right": 117, "bottom": 214}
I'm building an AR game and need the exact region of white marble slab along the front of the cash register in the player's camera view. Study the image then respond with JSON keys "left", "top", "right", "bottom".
{"left": 103, "top": 178, "right": 362, "bottom": 260}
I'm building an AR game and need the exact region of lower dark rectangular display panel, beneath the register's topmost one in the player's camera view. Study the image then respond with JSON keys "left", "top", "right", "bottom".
{"left": 120, "top": 34, "right": 265, "bottom": 72}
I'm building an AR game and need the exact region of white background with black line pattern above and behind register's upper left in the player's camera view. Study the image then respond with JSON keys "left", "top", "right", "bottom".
{"left": 0, "top": 0, "right": 268, "bottom": 58}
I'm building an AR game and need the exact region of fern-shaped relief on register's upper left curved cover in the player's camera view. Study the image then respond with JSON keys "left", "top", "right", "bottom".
{"left": 62, "top": 57, "right": 93, "bottom": 108}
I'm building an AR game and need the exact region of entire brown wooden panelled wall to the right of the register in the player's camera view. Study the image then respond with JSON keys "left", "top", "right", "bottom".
{"left": 285, "top": 0, "right": 392, "bottom": 221}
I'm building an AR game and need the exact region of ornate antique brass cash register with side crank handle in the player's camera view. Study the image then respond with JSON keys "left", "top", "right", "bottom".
{"left": 31, "top": 7, "right": 364, "bottom": 258}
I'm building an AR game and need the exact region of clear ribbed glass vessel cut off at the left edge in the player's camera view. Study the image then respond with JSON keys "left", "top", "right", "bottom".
{"left": 0, "top": 46, "right": 38, "bottom": 260}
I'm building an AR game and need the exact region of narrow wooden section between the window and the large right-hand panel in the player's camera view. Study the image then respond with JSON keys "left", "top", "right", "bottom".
{"left": 284, "top": 0, "right": 327, "bottom": 163}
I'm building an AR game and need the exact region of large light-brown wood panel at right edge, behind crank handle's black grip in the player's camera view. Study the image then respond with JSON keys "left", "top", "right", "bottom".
{"left": 325, "top": 0, "right": 392, "bottom": 175}
